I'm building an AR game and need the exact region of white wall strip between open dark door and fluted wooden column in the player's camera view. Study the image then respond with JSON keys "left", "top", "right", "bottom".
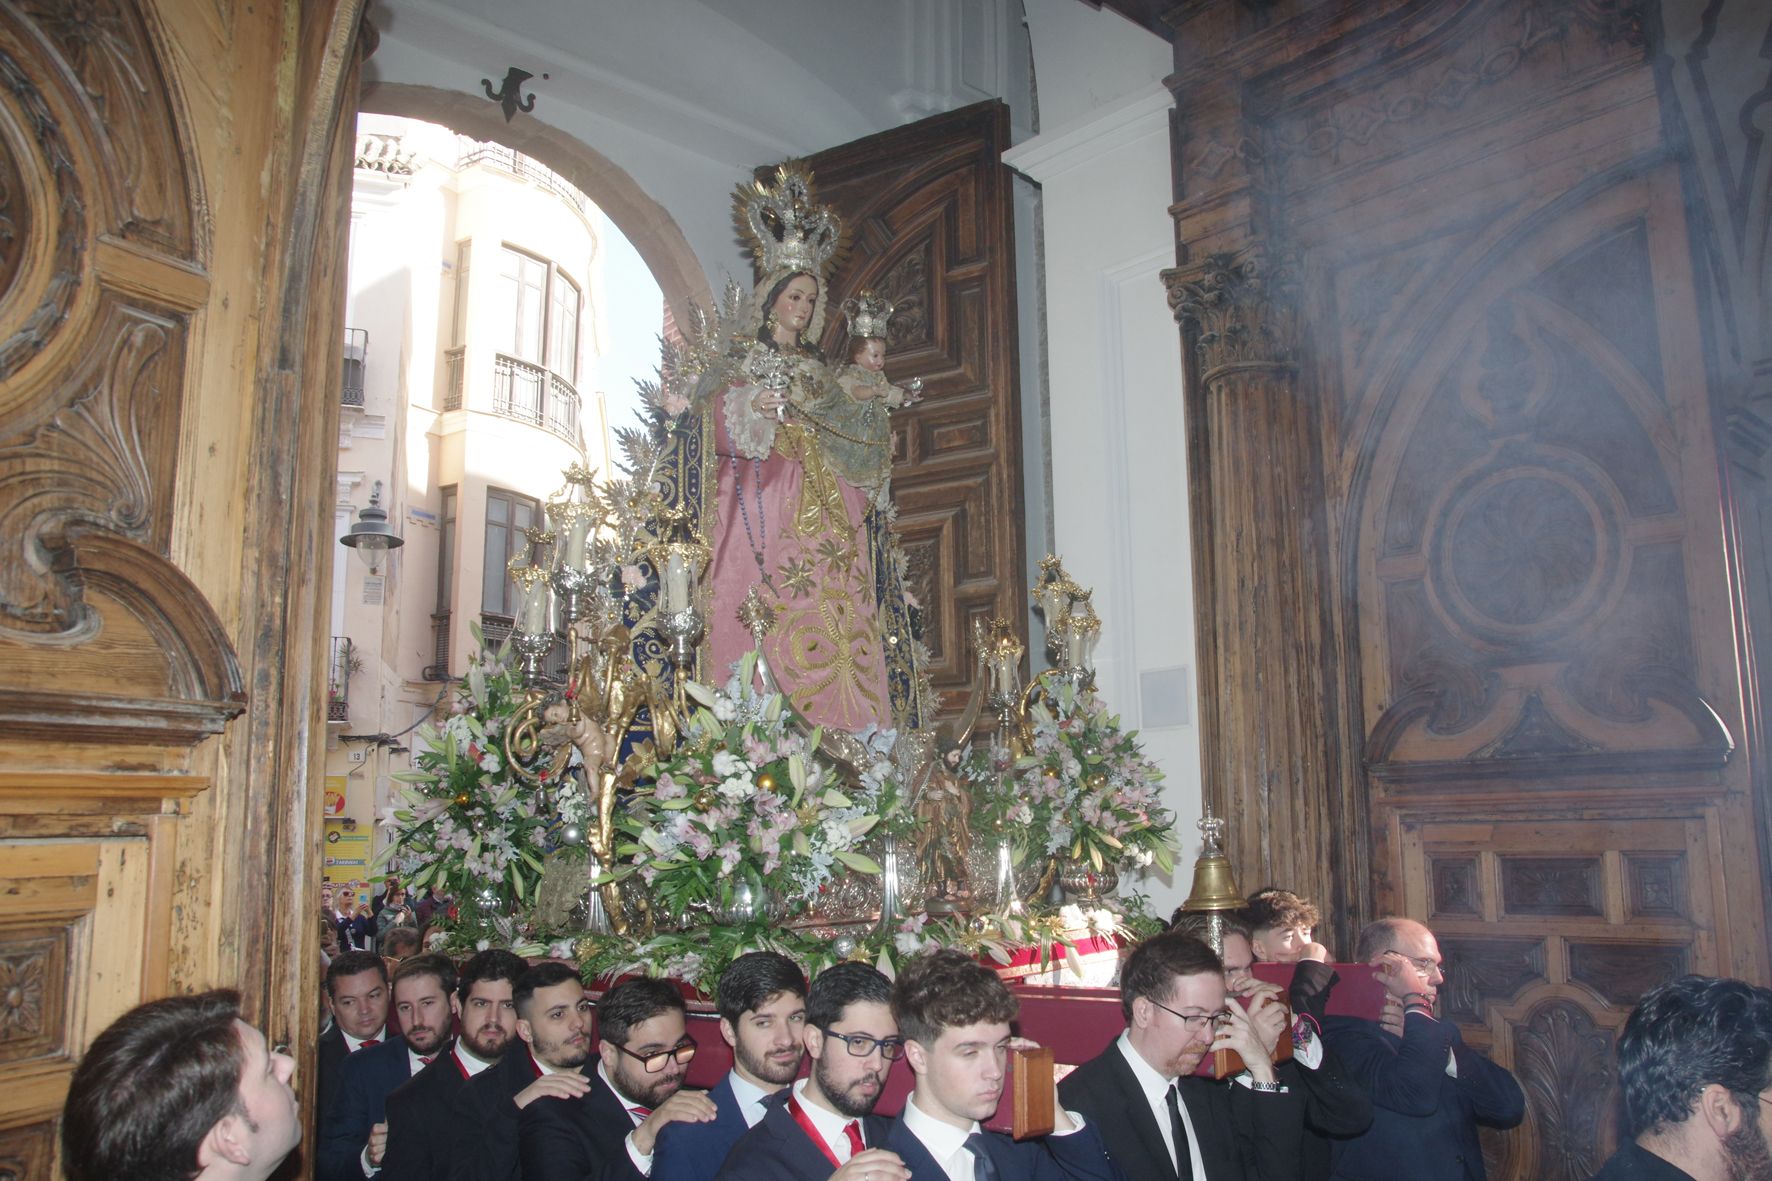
{"left": 1005, "top": 64, "right": 1201, "bottom": 915}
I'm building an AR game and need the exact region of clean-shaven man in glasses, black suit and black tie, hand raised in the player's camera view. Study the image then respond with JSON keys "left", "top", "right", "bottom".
{"left": 1058, "top": 931, "right": 1304, "bottom": 1181}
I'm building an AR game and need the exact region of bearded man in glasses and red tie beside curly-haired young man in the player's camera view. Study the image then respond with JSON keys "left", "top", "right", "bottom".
{"left": 719, "top": 961, "right": 911, "bottom": 1181}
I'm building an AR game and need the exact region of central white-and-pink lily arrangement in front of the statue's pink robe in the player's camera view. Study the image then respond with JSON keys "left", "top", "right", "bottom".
{"left": 604, "top": 656, "right": 898, "bottom": 926}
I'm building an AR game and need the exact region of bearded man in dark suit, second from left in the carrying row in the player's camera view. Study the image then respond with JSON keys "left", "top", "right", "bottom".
{"left": 315, "top": 956, "right": 455, "bottom": 1181}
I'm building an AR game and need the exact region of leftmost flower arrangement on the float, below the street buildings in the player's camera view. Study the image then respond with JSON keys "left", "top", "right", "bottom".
{"left": 376, "top": 628, "right": 590, "bottom": 926}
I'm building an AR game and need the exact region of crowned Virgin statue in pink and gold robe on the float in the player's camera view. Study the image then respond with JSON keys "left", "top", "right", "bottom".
{"left": 677, "top": 165, "right": 923, "bottom": 732}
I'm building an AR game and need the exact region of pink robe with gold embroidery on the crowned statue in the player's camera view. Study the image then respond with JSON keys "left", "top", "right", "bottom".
{"left": 709, "top": 372, "right": 893, "bottom": 731}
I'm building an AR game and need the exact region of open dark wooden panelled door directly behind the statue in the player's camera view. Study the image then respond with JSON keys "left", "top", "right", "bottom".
{"left": 808, "top": 103, "right": 1028, "bottom": 716}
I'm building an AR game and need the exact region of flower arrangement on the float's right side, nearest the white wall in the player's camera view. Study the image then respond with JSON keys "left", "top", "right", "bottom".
{"left": 962, "top": 684, "right": 1175, "bottom": 872}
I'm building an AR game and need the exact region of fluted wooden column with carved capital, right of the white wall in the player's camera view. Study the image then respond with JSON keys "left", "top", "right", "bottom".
{"left": 1162, "top": 245, "right": 1364, "bottom": 950}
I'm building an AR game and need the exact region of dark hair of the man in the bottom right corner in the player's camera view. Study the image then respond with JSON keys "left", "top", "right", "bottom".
{"left": 1618, "top": 975, "right": 1772, "bottom": 1140}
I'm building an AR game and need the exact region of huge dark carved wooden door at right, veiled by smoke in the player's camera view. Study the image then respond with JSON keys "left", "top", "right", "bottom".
{"left": 1170, "top": 0, "right": 1767, "bottom": 1181}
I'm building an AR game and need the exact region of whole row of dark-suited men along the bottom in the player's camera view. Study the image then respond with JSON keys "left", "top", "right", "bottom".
{"left": 62, "top": 883, "right": 1772, "bottom": 1181}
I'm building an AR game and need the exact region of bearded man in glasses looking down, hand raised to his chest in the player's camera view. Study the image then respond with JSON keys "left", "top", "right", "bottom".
{"left": 517, "top": 977, "right": 714, "bottom": 1181}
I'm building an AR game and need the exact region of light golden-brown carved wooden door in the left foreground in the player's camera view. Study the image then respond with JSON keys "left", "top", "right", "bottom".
{"left": 0, "top": 0, "right": 361, "bottom": 1181}
